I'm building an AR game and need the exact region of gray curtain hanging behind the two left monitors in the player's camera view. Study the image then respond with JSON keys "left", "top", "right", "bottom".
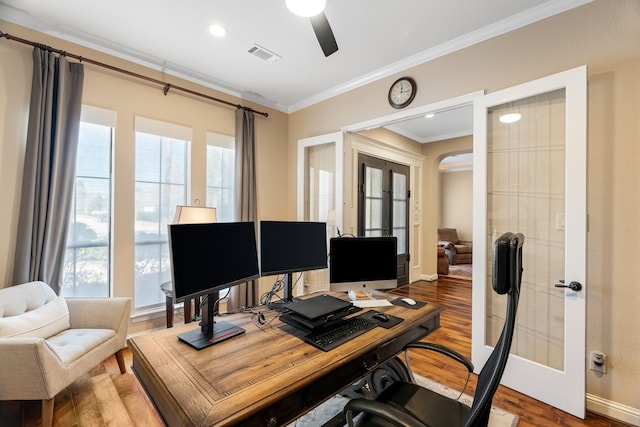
{"left": 227, "top": 108, "right": 259, "bottom": 310}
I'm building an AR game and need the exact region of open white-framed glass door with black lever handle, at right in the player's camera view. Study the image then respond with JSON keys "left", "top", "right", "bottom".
{"left": 472, "top": 67, "right": 588, "bottom": 418}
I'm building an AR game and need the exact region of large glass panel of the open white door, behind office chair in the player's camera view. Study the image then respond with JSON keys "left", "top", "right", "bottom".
{"left": 485, "top": 90, "right": 565, "bottom": 370}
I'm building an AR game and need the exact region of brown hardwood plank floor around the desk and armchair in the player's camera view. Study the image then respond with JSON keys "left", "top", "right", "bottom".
{"left": 0, "top": 279, "right": 627, "bottom": 427}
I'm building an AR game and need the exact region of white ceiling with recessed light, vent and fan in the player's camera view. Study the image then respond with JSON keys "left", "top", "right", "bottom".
{"left": 0, "top": 0, "right": 591, "bottom": 142}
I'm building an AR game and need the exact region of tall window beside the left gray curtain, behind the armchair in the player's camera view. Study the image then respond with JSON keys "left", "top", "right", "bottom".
{"left": 60, "top": 106, "right": 116, "bottom": 297}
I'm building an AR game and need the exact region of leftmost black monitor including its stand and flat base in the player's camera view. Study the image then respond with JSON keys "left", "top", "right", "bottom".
{"left": 168, "top": 222, "right": 260, "bottom": 349}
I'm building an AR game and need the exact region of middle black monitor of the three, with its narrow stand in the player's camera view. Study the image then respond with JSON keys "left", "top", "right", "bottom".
{"left": 260, "top": 221, "right": 327, "bottom": 304}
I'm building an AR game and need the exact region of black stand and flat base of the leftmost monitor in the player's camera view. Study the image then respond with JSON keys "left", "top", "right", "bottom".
{"left": 178, "top": 292, "right": 245, "bottom": 350}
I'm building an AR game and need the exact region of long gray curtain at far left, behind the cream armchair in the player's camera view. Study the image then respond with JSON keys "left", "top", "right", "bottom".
{"left": 13, "top": 47, "right": 84, "bottom": 294}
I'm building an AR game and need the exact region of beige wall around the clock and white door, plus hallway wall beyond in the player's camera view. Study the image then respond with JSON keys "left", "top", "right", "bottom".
{"left": 289, "top": 0, "right": 640, "bottom": 413}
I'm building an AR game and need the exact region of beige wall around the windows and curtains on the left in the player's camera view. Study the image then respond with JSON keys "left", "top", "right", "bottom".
{"left": 0, "top": 21, "right": 295, "bottom": 332}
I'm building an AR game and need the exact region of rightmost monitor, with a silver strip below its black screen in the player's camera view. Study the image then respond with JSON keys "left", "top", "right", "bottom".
{"left": 329, "top": 237, "right": 398, "bottom": 292}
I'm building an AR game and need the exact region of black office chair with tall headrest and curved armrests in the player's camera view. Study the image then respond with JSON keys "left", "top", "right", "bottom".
{"left": 343, "top": 233, "right": 524, "bottom": 427}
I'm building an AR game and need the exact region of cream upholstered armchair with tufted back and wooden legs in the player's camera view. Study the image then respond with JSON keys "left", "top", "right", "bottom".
{"left": 0, "top": 282, "right": 131, "bottom": 427}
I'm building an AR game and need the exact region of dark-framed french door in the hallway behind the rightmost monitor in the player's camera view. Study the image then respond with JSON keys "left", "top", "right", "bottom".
{"left": 358, "top": 153, "right": 410, "bottom": 285}
